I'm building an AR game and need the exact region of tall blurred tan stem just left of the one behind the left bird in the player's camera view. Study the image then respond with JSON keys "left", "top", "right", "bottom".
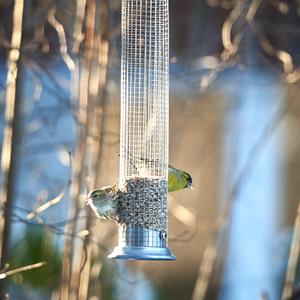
{"left": 61, "top": 0, "right": 96, "bottom": 300}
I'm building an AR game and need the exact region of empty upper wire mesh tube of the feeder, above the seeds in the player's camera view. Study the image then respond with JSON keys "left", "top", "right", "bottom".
{"left": 120, "top": 0, "right": 169, "bottom": 183}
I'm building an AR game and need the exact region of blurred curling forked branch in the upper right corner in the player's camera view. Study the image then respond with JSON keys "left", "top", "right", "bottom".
{"left": 200, "top": 0, "right": 300, "bottom": 89}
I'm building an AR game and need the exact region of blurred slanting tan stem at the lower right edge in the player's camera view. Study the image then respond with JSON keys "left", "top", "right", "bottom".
{"left": 281, "top": 202, "right": 300, "bottom": 300}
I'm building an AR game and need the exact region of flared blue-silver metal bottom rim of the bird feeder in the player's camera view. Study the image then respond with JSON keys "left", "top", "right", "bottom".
{"left": 108, "top": 246, "right": 176, "bottom": 260}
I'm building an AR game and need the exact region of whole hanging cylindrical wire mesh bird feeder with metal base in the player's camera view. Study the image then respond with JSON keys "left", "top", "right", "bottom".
{"left": 109, "top": 0, "right": 175, "bottom": 260}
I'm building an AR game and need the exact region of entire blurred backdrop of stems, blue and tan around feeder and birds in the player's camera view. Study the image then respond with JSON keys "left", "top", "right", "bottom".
{"left": 0, "top": 0, "right": 300, "bottom": 300}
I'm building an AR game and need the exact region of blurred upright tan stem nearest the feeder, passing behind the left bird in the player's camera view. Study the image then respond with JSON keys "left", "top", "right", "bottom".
{"left": 77, "top": 0, "right": 110, "bottom": 299}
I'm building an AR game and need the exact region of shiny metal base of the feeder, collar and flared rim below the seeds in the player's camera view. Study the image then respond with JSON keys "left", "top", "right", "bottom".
{"left": 108, "top": 225, "right": 176, "bottom": 260}
